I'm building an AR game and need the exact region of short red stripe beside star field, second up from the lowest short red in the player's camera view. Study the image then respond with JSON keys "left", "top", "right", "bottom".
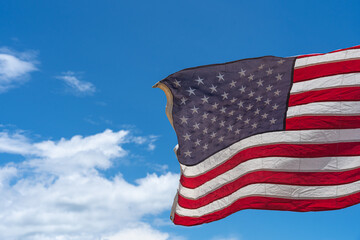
{"left": 289, "top": 87, "right": 360, "bottom": 107}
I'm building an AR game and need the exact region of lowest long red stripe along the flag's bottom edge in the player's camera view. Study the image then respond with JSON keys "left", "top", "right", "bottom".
{"left": 174, "top": 190, "right": 360, "bottom": 226}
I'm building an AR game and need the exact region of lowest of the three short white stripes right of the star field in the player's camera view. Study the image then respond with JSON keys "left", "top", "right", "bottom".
{"left": 286, "top": 101, "right": 360, "bottom": 118}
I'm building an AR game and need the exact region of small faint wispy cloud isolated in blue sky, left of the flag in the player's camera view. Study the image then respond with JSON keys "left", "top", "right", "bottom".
{"left": 56, "top": 71, "right": 96, "bottom": 95}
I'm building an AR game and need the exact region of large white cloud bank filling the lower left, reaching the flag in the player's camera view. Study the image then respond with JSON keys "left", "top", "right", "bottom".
{"left": 0, "top": 130, "right": 179, "bottom": 240}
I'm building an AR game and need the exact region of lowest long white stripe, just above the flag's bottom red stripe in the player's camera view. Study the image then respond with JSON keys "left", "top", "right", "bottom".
{"left": 176, "top": 181, "right": 360, "bottom": 217}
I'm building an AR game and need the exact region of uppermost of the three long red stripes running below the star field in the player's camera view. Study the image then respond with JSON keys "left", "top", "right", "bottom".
{"left": 180, "top": 142, "right": 360, "bottom": 188}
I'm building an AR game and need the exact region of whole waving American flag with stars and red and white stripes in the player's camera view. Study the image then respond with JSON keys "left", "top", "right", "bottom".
{"left": 155, "top": 46, "right": 360, "bottom": 226}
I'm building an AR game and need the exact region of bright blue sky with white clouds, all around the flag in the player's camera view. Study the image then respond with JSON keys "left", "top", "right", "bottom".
{"left": 0, "top": 0, "right": 360, "bottom": 240}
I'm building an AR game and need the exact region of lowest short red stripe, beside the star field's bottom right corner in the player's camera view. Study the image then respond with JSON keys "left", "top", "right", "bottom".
{"left": 286, "top": 116, "right": 360, "bottom": 130}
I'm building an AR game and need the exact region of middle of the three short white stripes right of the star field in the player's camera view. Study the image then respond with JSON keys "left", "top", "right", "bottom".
{"left": 290, "top": 73, "right": 360, "bottom": 94}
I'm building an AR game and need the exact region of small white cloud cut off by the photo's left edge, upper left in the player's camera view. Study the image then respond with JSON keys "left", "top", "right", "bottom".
{"left": 0, "top": 48, "right": 37, "bottom": 93}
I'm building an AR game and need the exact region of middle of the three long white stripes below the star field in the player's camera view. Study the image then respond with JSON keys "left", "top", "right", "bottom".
{"left": 179, "top": 156, "right": 360, "bottom": 199}
